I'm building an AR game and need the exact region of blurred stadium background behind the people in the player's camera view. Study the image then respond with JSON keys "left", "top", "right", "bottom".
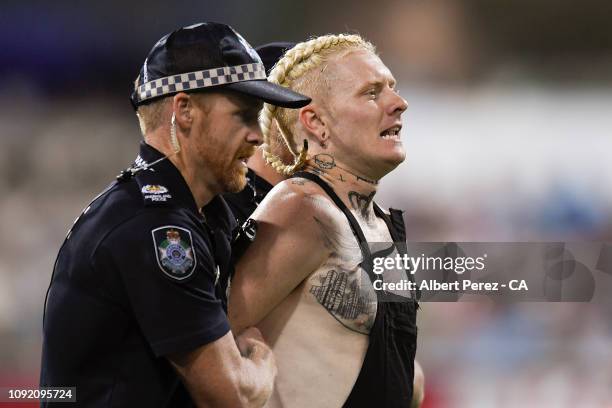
{"left": 0, "top": 0, "right": 612, "bottom": 408}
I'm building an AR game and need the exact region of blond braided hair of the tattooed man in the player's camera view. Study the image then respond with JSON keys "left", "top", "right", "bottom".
{"left": 259, "top": 34, "right": 375, "bottom": 176}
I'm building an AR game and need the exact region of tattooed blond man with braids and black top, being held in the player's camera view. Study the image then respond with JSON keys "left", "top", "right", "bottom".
{"left": 229, "top": 35, "right": 417, "bottom": 407}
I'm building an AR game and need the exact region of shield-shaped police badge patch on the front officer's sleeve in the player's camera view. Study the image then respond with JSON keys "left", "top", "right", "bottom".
{"left": 151, "top": 225, "right": 197, "bottom": 281}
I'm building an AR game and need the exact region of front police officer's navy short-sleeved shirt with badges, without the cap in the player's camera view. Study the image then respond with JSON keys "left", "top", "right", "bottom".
{"left": 41, "top": 143, "right": 235, "bottom": 407}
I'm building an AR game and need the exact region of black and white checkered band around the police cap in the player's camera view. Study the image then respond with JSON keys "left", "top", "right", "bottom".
{"left": 137, "top": 63, "right": 266, "bottom": 102}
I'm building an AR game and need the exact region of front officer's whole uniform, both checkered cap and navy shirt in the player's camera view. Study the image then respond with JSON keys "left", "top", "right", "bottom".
{"left": 41, "top": 22, "right": 310, "bottom": 407}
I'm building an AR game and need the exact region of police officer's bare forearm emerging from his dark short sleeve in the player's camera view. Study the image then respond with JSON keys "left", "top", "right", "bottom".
{"left": 169, "top": 328, "right": 276, "bottom": 408}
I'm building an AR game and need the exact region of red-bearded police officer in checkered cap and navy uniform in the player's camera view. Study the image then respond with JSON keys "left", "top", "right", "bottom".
{"left": 41, "top": 23, "right": 309, "bottom": 407}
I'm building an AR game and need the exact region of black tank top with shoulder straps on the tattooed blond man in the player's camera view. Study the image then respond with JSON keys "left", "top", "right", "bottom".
{"left": 294, "top": 172, "right": 418, "bottom": 408}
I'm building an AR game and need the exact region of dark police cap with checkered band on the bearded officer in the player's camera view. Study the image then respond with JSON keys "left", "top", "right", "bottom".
{"left": 131, "top": 22, "right": 310, "bottom": 108}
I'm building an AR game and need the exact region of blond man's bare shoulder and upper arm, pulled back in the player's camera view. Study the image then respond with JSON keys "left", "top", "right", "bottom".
{"left": 229, "top": 181, "right": 329, "bottom": 330}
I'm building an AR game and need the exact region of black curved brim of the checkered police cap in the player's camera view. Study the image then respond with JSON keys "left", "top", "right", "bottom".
{"left": 223, "top": 80, "right": 311, "bottom": 109}
